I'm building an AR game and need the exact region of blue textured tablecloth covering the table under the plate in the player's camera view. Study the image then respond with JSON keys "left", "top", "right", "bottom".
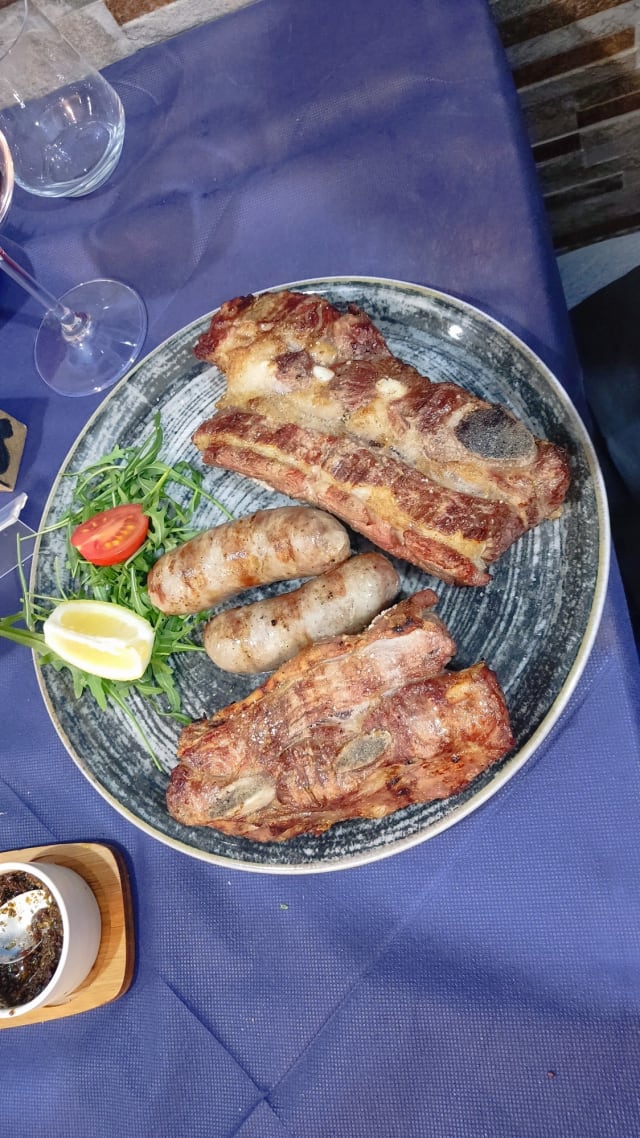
{"left": 0, "top": 0, "right": 640, "bottom": 1138}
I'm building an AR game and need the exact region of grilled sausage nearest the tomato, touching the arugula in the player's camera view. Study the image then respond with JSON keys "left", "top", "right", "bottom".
{"left": 147, "top": 505, "right": 351, "bottom": 615}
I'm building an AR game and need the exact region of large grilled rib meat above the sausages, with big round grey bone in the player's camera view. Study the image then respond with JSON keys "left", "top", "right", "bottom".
{"left": 194, "top": 291, "right": 569, "bottom": 585}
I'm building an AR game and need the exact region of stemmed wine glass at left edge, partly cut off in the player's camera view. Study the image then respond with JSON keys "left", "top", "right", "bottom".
{"left": 0, "top": 133, "right": 147, "bottom": 396}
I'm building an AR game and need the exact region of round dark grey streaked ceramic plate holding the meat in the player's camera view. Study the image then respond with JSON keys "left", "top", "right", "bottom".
{"left": 32, "top": 278, "right": 609, "bottom": 873}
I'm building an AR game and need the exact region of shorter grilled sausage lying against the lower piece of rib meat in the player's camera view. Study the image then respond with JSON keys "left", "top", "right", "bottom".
{"left": 203, "top": 553, "right": 400, "bottom": 674}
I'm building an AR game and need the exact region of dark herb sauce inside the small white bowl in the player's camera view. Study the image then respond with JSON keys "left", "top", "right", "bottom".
{"left": 0, "top": 872, "right": 63, "bottom": 1009}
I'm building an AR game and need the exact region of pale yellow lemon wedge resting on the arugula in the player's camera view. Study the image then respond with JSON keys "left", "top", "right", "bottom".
{"left": 42, "top": 601, "right": 154, "bottom": 679}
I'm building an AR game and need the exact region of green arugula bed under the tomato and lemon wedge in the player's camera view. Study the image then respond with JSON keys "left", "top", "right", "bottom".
{"left": 0, "top": 413, "right": 233, "bottom": 765}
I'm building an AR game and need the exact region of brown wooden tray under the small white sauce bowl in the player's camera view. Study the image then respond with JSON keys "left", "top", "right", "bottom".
{"left": 0, "top": 842, "right": 134, "bottom": 1030}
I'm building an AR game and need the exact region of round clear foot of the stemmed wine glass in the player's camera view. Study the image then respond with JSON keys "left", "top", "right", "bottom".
{"left": 34, "top": 280, "right": 147, "bottom": 396}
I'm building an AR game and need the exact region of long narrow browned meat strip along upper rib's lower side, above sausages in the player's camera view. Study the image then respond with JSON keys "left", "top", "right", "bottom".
{"left": 189, "top": 411, "right": 524, "bottom": 585}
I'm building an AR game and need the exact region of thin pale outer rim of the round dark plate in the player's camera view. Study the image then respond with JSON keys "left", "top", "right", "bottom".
{"left": 30, "top": 274, "right": 610, "bottom": 876}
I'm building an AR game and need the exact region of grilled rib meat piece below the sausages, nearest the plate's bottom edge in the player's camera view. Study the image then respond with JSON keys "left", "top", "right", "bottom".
{"left": 167, "top": 589, "right": 512, "bottom": 841}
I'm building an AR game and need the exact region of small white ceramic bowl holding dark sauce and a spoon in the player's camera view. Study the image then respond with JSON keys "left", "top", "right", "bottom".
{"left": 0, "top": 861, "right": 101, "bottom": 1019}
